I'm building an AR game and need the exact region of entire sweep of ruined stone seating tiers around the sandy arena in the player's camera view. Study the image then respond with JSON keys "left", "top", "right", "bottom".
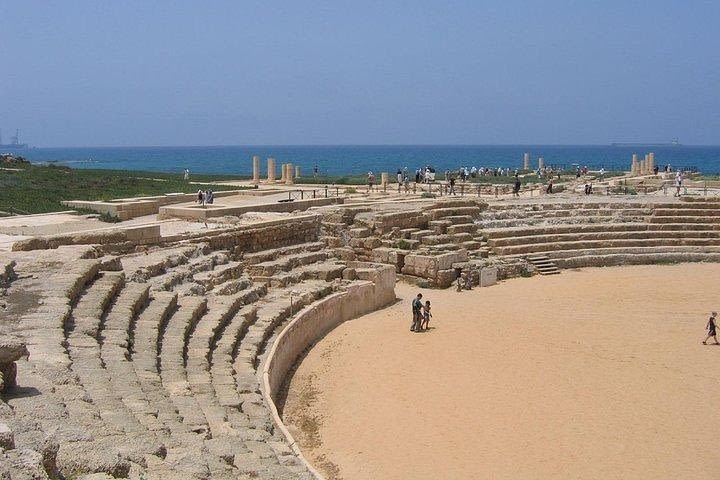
{"left": 0, "top": 174, "right": 720, "bottom": 480}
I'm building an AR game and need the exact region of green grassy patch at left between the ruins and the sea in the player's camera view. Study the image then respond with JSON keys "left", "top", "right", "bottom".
{"left": 0, "top": 165, "right": 247, "bottom": 214}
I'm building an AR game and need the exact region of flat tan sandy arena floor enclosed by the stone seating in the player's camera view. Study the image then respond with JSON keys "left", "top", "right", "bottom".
{"left": 284, "top": 264, "right": 720, "bottom": 480}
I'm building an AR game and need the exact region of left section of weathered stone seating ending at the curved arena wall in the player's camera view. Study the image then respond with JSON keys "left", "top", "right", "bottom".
{"left": 0, "top": 214, "right": 395, "bottom": 479}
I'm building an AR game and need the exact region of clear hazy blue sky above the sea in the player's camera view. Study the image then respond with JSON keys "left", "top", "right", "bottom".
{"left": 0, "top": 0, "right": 720, "bottom": 146}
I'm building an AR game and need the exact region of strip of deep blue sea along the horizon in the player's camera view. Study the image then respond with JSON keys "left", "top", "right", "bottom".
{"left": 14, "top": 145, "right": 720, "bottom": 177}
